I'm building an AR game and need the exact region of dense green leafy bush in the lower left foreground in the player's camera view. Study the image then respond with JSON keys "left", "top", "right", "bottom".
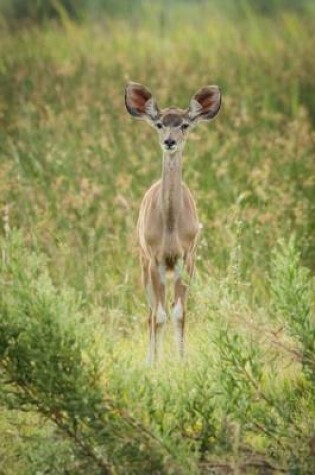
{"left": 0, "top": 235, "right": 183, "bottom": 473}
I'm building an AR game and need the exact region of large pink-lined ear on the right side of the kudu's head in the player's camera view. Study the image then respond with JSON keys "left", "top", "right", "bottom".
{"left": 188, "top": 86, "right": 221, "bottom": 122}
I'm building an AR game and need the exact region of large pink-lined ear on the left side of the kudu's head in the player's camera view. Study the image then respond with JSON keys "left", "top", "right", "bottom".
{"left": 125, "top": 82, "right": 159, "bottom": 120}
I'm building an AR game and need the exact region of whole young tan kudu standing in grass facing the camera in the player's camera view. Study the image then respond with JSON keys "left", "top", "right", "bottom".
{"left": 125, "top": 83, "right": 221, "bottom": 363}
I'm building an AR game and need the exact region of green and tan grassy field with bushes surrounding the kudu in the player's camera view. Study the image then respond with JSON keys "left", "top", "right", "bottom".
{"left": 0, "top": 2, "right": 315, "bottom": 475}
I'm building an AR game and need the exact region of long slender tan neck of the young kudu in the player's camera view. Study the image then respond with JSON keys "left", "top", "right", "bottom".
{"left": 161, "top": 151, "right": 182, "bottom": 232}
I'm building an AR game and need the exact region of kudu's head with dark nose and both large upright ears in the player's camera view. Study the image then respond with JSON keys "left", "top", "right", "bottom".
{"left": 125, "top": 82, "right": 221, "bottom": 153}
